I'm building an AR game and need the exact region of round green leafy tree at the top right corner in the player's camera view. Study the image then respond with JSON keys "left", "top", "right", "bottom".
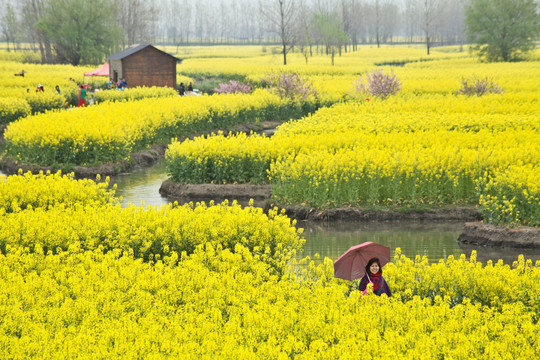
{"left": 466, "top": 0, "right": 540, "bottom": 62}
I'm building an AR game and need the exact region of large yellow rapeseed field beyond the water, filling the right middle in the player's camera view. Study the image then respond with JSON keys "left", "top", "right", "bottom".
{"left": 167, "top": 54, "right": 540, "bottom": 226}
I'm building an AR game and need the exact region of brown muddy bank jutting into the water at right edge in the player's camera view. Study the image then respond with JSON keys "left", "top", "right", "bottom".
{"left": 458, "top": 222, "right": 540, "bottom": 249}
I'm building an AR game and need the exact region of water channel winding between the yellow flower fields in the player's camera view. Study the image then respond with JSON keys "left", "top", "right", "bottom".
{"left": 111, "top": 160, "right": 540, "bottom": 264}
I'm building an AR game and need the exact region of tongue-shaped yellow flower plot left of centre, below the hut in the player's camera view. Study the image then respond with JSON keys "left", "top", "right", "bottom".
{"left": 5, "top": 90, "right": 312, "bottom": 165}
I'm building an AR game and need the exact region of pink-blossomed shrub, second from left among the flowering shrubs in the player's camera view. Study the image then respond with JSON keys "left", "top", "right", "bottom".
{"left": 261, "top": 73, "right": 317, "bottom": 100}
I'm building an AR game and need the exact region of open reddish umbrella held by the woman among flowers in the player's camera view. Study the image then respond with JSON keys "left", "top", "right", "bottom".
{"left": 334, "top": 241, "right": 390, "bottom": 280}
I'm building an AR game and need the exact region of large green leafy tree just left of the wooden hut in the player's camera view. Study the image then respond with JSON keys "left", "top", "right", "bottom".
{"left": 38, "top": 0, "right": 121, "bottom": 65}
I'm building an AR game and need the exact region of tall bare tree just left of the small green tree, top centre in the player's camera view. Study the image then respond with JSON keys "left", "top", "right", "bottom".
{"left": 260, "top": 0, "right": 297, "bottom": 65}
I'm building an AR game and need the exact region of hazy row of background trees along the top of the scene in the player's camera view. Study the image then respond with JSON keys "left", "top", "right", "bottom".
{"left": 0, "top": 0, "right": 538, "bottom": 64}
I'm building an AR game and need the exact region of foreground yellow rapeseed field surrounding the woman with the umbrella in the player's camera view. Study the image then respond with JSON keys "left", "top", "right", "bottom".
{"left": 0, "top": 173, "right": 540, "bottom": 359}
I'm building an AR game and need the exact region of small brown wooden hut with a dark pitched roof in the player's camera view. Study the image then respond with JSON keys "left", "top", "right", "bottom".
{"left": 107, "top": 44, "right": 181, "bottom": 88}
